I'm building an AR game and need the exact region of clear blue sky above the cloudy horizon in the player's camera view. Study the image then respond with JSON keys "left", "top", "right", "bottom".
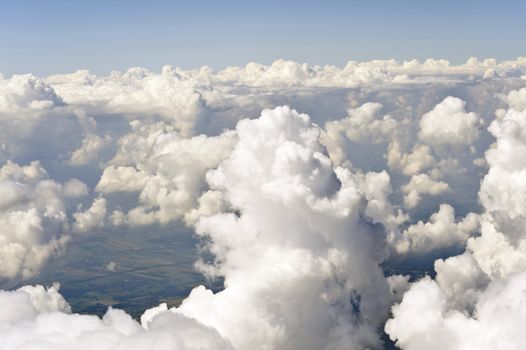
{"left": 0, "top": 0, "right": 526, "bottom": 76}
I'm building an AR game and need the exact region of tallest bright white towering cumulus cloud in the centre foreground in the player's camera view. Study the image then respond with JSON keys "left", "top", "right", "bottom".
{"left": 171, "top": 107, "right": 398, "bottom": 349}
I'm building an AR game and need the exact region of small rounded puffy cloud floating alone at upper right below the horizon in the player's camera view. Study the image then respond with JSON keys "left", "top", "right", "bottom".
{"left": 418, "top": 96, "right": 482, "bottom": 146}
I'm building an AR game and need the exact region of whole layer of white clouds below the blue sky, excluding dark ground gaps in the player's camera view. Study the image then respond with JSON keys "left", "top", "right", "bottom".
{"left": 0, "top": 58, "right": 526, "bottom": 350}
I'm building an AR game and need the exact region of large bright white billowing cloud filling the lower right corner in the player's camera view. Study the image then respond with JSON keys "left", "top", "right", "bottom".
{"left": 385, "top": 103, "right": 526, "bottom": 349}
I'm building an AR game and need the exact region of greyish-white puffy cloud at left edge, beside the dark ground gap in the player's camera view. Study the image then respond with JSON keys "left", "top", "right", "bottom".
{"left": 0, "top": 162, "right": 69, "bottom": 278}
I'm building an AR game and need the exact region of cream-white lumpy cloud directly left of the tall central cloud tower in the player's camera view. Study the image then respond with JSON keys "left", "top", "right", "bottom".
{"left": 96, "top": 121, "right": 235, "bottom": 225}
